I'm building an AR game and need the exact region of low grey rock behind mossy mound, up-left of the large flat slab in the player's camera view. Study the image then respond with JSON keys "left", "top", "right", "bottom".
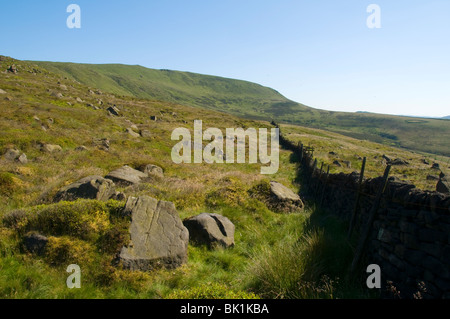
{"left": 53, "top": 176, "right": 116, "bottom": 202}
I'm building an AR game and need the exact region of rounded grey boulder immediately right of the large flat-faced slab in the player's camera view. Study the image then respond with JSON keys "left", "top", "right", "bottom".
{"left": 183, "top": 213, "right": 235, "bottom": 248}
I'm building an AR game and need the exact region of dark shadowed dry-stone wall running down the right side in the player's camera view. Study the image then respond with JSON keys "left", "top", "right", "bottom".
{"left": 280, "top": 132, "right": 450, "bottom": 299}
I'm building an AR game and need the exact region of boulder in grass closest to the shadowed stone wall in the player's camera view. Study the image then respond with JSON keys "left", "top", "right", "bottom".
{"left": 270, "top": 181, "right": 304, "bottom": 212}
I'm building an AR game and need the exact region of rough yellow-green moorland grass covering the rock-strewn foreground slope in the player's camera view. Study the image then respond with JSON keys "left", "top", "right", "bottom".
{"left": 0, "top": 53, "right": 436, "bottom": 298}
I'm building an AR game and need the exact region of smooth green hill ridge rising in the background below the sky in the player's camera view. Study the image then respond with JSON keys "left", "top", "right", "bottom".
{"left": 34, "top": 62, "right": 450, "bottom": 156}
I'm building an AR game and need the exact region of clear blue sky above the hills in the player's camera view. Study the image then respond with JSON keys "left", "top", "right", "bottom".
{"left": 0, "top": 0, "right": 450, "bottom": 116}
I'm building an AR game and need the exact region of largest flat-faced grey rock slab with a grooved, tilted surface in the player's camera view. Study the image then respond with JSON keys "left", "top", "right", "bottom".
{"left": 119, "top": 196, "right": 189, "bottom": 271}
